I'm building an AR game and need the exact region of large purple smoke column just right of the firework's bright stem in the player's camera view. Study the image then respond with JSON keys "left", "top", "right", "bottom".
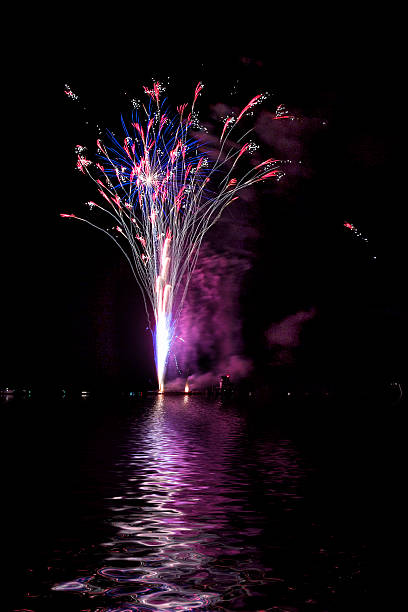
{"left": 167, "top": 232, "right": 252, "bottom": 388}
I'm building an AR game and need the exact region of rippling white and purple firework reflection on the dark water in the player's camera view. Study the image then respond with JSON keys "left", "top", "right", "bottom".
{"left": 53, "top": 396, "right": 305, "bottom": 611}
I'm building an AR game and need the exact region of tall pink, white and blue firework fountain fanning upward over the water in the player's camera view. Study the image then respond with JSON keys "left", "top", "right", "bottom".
{"left": 61, "top": 83, "right": 283, "bottom": 391}
